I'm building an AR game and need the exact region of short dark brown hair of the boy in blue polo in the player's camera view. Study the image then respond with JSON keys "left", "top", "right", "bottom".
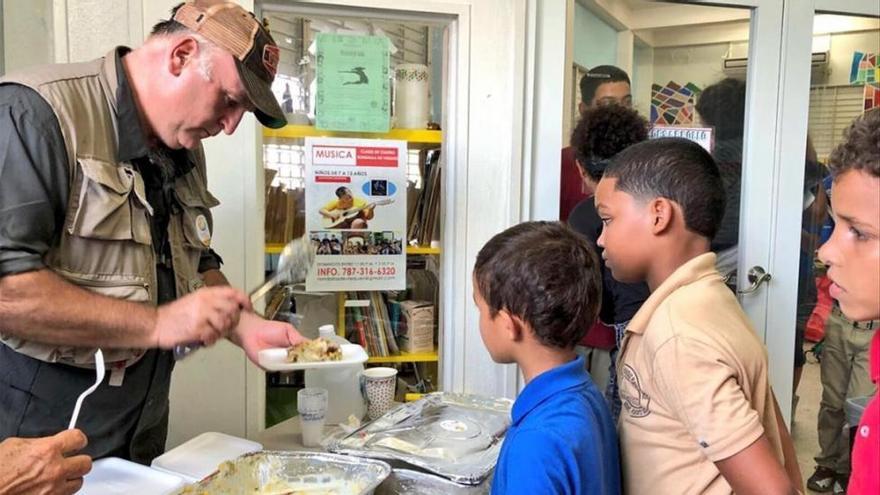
{"left": 474, "top": 222, "right": 602, "bottom": 349}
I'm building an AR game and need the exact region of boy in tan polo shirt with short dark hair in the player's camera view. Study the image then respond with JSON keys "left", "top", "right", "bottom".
{"left": 596, "top": 139, "right": 802, "bottom": 494}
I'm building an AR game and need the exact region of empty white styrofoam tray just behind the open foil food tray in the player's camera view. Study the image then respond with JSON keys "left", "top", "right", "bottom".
{"left": 151, "top": 431, "right": 263, "bottom": 482}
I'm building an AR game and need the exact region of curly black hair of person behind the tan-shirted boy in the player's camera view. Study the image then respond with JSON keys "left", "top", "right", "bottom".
{"left": 571, "top": 105, "right": 648, "bottom": 181}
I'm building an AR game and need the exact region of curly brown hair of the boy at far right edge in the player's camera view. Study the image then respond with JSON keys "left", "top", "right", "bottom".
{"left": 828, "top": 108, "right": 880, "bottom": 177}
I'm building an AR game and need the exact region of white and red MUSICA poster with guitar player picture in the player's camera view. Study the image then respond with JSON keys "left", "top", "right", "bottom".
{"left": 305, "top": 138, "right": 407, "bottom": 292}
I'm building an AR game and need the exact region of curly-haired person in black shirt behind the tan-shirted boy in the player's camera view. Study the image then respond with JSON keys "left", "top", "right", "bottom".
{"left": 568, "top": 105, "right": 650, "bottom": 419}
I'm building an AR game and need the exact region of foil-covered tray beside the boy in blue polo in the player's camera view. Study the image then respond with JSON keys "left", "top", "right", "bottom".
{"left": 328, "top": 392, "right": 513, "bottom": 485}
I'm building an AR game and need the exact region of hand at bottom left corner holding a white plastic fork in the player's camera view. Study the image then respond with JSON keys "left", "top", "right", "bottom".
{"left": 0, "top": 430, "right": 92, "bottom": 495}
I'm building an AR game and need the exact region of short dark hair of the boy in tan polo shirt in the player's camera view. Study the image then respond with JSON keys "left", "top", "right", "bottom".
{"left": 605, "top": 138, "right": 724, "bottom": 240}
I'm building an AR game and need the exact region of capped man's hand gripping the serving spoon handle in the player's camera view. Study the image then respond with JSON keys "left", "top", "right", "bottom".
{"left": 153, "top": 287, "right": 251, "bottom": 349}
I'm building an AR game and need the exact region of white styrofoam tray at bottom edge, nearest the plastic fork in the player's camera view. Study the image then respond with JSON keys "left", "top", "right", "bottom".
{"left": 77, "top": 457, "right": 186, "bottom": 495}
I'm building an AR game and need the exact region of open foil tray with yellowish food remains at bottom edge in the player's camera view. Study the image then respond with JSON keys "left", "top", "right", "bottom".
{"left": 177, "top": 450, "right": 391, "bottom": 495}
